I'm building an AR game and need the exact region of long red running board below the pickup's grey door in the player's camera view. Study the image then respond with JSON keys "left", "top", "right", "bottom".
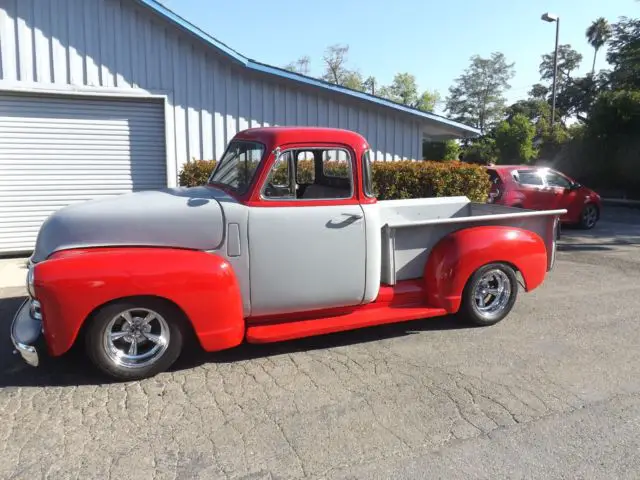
{"left": 246, "top": 304, "right": 447, "bottom": 343}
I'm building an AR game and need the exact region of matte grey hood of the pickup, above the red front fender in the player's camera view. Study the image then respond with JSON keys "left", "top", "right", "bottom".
{"left": 31, "top": 187, "right": 235, "bottom": 263}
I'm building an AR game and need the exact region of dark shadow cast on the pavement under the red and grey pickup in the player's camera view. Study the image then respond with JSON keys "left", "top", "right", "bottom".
{"left": 0, "top": 297, "right": 474, "bottom": 388}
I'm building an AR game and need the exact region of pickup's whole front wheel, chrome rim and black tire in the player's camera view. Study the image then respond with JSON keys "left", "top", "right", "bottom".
{"left": 85, "top": 299, "right": 184, "bottom": 380}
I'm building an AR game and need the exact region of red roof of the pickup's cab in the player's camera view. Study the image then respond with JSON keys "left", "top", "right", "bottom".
{"left": 235, "top": 126, "right": 369, "bottom": 148}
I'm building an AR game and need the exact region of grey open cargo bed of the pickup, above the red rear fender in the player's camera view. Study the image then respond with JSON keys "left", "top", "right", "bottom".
{"left": 379, "top": 197, "right": 566, "bottom": 285}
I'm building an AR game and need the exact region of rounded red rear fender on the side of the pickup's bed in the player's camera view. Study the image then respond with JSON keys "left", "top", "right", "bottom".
{"left": 424, "top": 226, "right": 547, "bottom": 313}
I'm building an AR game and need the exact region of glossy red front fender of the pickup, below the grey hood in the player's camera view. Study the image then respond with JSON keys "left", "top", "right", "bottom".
{"left": 34, "top": 248, "right": 244, "bottom": 356}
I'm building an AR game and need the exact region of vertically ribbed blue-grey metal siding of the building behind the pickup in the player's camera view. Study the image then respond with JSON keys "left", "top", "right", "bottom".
{"left": 0, "top": 0, "right": 420, "bottom": 188}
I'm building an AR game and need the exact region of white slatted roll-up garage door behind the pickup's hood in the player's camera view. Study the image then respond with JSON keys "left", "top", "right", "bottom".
{"left": 0, "top": 94, "right": 167, "bottom": 254}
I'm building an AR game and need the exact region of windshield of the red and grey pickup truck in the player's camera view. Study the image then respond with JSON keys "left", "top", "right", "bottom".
{"left": 209, "top": 140, "right": 265, "bottom": 194}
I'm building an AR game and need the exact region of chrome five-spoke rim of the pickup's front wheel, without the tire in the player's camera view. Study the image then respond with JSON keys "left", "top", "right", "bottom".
{"left": 103, "top": 308, "right": 171, "bottom": 368}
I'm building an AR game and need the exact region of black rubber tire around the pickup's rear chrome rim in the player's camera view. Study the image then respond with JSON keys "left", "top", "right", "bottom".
{"left": 459, "top": 263, "right": 518, "bottom": 327}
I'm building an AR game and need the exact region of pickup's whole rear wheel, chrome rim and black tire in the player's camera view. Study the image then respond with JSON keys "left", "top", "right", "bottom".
{"left": 460, "top": 263, "right": 518, "bottom": 326}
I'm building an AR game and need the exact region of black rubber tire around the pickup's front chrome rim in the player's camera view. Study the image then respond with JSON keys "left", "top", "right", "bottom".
{"left": 84, "top": 298, "right": 185, "bottom": 381}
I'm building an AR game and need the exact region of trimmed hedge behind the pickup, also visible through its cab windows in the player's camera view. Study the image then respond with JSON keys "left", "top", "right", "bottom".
{"left": 180, "top": 160, "right": 490, "bottom": 202}
